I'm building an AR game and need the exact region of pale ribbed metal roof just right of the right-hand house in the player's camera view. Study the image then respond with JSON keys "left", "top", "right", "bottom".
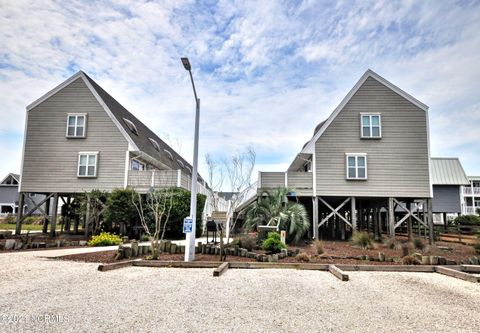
{"left": 431, "top": 157, "right": 470, "bottom": 185}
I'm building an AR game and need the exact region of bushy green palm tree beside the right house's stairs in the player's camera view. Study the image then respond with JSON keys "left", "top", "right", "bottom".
{"left": 245, "top": 187, "right": 310, "bottom": 243}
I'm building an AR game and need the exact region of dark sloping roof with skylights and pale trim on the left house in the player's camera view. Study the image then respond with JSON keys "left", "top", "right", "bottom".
{"left": 27, "top": 71, "right": 202, "bottom": 181}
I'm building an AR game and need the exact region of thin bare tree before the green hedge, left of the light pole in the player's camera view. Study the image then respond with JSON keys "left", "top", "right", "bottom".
{"left": 132, "top": 188, "right": 173, "bottom": 259}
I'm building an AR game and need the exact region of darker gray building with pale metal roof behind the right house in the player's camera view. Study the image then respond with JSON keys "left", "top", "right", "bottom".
{"left": 432, "top": 157, "right": 469, "bottom": 223}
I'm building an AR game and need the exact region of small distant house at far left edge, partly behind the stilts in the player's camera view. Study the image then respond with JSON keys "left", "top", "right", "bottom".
{"left": 0, "top": 173, "right": 45, "bottom": 216}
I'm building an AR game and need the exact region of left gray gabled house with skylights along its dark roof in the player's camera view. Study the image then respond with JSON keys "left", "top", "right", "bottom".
{"left": 17, "top": 71, "right": 212, "bottom": 234}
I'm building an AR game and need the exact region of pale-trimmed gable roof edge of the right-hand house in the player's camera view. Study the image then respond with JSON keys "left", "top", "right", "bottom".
{"left": 301, "top": 69, "right": 428, "bottom": 154}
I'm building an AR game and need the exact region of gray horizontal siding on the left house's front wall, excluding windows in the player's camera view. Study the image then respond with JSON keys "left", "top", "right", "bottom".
{"left": 21, "top": 77, "right": 128, "bottom": 193}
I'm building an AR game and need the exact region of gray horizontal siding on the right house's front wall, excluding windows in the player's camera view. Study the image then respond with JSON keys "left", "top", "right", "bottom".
{"left": 315, "top": 77, "right": 430, "bottom": 198}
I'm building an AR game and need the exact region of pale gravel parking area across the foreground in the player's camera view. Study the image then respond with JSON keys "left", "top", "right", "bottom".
{"left": 0, "top": 253, "right": 480, "bottom": 332}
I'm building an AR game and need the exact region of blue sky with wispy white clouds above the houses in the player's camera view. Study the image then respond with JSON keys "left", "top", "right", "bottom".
{"left": 0, "top": 0, "right": 480, "bottom": 187}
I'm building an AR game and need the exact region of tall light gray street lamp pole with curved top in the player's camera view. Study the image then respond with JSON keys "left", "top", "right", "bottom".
{"left": 181, "top": 58, "right": 200, "bottom": 261}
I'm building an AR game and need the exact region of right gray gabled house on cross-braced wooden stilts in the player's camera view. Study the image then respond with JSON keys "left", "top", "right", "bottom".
{"left": 258, "top": 70, "right": 433, "bottom": 239}
